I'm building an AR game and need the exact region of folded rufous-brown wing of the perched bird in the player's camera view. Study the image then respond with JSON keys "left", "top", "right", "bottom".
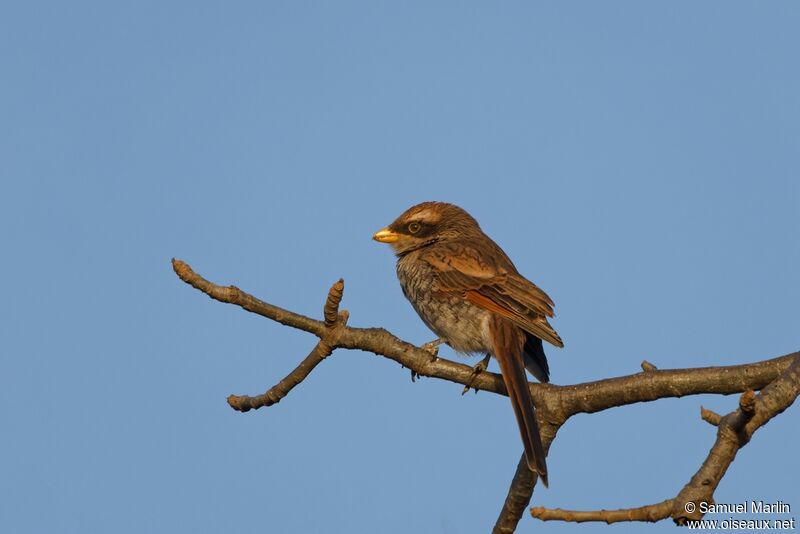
{"left": 424, "top": 241, "right": 564, "bottom": 347}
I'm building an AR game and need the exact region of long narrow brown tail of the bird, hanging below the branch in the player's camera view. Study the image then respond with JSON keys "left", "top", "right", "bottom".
{"left": 490, "top": 317, "right": 547, "bottom": 486}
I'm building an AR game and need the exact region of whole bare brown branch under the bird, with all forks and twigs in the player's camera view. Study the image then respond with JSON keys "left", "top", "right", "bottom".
{"left": 172, "top": 259, "right": 800, "bottom": 533}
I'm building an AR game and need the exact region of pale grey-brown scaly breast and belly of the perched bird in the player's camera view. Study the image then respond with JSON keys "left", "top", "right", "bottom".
{"left": 397, "top": 253, "right": 491, "bottom": 353}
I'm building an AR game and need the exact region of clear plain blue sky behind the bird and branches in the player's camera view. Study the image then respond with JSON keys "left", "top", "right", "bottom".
{"left": 0, "top": 0, "right": 800, "bottom": 534}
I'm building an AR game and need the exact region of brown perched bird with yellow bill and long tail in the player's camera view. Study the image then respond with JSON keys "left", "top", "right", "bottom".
{"left": 373, "top": 202, "right": 564, "bottom": 485}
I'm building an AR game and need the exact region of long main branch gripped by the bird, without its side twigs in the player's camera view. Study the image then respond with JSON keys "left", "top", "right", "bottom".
{"left": 172, "top": 259, "right": 797, "bottom": 414}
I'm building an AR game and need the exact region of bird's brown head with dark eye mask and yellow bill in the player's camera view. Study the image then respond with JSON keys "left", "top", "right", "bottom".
{"left": 372, "top": 202, "right": 481, "bottom": 256}
